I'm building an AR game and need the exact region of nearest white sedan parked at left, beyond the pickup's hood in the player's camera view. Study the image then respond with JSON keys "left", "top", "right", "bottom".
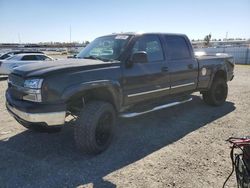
{"left": 0, "top": 53, "right": 53, "bottom": 75}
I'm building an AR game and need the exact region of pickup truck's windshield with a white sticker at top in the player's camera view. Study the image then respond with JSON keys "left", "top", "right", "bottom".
{"left": 76, "top": 35, "right": 131, "bottom": 61}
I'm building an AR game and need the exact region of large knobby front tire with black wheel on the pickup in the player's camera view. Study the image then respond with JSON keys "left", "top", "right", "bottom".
{"left": 74, "top": 101, "right": 116, "bottom": 154}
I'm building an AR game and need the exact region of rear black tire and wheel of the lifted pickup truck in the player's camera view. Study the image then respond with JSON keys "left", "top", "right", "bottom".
{"left": 202, "top": 78, "right": 228, "bottom": 106}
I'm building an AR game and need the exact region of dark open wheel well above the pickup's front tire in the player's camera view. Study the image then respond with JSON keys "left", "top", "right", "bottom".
{"left": 67, "top": 87, "right": 117, "bottom": 113}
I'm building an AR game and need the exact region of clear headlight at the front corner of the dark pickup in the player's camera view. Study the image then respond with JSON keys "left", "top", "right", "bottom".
{"left": 23, "top": 79, "right": 43, "bottom": 102}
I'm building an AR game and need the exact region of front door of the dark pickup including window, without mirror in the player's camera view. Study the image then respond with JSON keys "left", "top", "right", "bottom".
{"left": 122, "top": 34, "right": 170, "bottom": 105}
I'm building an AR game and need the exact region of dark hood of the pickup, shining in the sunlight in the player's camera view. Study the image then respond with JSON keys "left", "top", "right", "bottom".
{"left": 12, "top": 59, "right": 120, "bottom": 78}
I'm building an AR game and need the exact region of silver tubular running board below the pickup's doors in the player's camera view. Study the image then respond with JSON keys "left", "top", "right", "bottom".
{"left": 120, "top": 98, "right": 192, "bottom": 118}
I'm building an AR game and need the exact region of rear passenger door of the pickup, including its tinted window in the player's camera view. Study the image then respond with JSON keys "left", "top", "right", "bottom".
{"left": 164, "top": 35, "right": 198, "bottom": 94}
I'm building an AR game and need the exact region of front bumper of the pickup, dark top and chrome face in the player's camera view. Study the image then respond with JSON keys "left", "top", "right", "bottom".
{"left": 6, "top": 93, "right": 66, "bottom": 126}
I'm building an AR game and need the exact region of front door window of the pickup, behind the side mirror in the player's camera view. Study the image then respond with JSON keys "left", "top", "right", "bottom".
{"left": 132, "top": 35, "right": 164, "bottom": 62}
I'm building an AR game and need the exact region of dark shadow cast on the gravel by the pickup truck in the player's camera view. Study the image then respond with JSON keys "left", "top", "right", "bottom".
{"left": 0, "top": 96, "right": 235, "bottom": 187}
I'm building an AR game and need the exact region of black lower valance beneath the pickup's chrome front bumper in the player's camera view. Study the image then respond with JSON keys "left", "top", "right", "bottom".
{"left": 15, "top": 118, "right": 61, "bottom": 133}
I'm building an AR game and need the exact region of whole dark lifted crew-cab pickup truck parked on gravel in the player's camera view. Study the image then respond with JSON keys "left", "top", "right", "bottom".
{"left": 6, "top": 33, "right": 234, "bottom": 153}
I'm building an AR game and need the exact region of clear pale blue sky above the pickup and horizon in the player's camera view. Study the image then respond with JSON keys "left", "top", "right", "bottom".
{"left": 0, "top": 0, "right": 250, "bottom": 43}
